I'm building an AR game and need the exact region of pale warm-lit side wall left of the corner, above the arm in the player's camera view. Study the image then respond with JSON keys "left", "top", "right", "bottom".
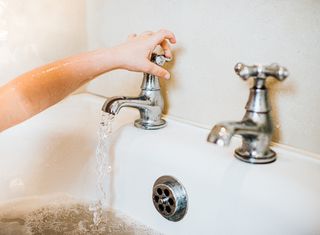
{"left": 0, "top": 0, "right": 87, "bottom": 85}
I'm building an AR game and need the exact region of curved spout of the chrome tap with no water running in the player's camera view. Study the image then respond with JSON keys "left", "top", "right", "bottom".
{"left": 207, "top": 121, "right": 261, "bottom": 146}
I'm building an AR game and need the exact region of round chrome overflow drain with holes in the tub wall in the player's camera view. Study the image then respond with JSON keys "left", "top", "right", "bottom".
{"left": 152, "top": 176, "right": 188, "bottom": 222}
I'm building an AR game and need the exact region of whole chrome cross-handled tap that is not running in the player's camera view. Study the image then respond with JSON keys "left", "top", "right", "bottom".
{"left": 208, "top": 63, "right": 289, "bottom": 164}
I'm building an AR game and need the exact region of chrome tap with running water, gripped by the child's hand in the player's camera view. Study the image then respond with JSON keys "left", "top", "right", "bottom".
{"left": 102, "top": 54, "right": 171, "bottom": 130}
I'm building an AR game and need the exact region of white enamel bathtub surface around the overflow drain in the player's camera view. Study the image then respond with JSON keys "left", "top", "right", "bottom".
{"left": 0, "top": 94, "right": 320, "bottom": 234}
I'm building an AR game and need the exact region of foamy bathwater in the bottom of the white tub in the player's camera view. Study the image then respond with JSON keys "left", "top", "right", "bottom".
{"left": 0, "top": 194, "right": 159, "bottom": 235}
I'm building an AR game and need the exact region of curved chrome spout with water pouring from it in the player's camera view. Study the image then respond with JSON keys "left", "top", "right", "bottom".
{"left": 102, "top": 96, "right": 151, "bottom": 115}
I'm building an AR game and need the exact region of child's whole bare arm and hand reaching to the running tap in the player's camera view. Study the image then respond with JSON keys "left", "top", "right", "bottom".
{"left": 0, "top": 30, "right": 176, "bottom": 131}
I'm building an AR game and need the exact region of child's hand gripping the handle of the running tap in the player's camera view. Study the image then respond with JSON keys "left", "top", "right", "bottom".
{"left": 111, "top": 29, "right": 176, "bottom": 79}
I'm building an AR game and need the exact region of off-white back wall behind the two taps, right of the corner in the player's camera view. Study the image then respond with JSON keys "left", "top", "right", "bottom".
{"left": 87, "top": 0, "right": 320, "bottom": 153}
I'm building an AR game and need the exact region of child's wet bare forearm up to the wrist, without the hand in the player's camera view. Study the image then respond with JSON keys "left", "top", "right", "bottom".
{"left": 0, "top": 49, "right": 116, "bottom": 130}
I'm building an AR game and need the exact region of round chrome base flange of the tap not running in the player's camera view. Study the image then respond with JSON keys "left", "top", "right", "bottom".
{"left": 234, "top": 148, "right": 277, "bottom": 164}
